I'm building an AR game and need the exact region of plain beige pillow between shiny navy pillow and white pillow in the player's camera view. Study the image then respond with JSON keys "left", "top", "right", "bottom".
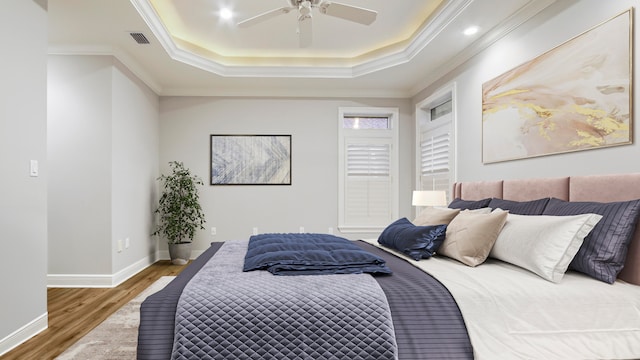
{"left": 438, "top": 209, "right": 509, "bottom": 266}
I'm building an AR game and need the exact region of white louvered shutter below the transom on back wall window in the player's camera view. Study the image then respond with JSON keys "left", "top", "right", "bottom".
{"left": 344, "top": 139, "right": 392, "bottom": 227}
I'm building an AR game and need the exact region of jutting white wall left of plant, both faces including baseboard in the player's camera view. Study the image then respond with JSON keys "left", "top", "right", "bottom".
{"left": 48, "top": 55, "right": 159, "bottom": 286}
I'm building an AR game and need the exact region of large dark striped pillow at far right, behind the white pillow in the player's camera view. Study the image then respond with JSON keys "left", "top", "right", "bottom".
{"left": 544, "top": 198, "right": 640, "bottom": 284}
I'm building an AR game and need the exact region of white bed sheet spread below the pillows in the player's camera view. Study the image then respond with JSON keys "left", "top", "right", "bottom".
{"left": 365, "top": 239, "right": 640, "bottom": 360}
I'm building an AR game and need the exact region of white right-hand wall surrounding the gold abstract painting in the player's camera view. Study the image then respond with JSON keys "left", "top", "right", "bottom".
{"left": 413, "top": 0, "right": 640, "bottom": 181}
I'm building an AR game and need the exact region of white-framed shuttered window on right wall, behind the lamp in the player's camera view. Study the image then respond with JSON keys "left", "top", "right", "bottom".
{"left": 416, "top": 88, "right": 455, "bottom": 201}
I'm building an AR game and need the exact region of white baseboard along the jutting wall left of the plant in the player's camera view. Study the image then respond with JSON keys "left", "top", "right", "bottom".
{"left": 47, "top": 257, "right": 156, "bottom": 288}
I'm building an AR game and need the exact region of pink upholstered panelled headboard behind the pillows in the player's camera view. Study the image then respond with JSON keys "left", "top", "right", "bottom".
{"left": 453, "top": 173, "right": 640, "bottom": 285}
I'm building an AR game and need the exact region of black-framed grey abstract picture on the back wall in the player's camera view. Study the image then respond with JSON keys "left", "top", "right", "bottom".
{"left": 210, "top": 135, "right": 291, "bottom": 185}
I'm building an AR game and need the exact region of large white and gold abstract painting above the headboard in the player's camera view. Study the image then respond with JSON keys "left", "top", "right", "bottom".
{"left": 482, "top": 8, "right": 633, "bottom": 164}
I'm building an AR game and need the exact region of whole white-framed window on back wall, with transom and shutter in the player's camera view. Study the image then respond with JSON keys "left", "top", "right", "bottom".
{"left": 338, "top": 108, "right": 398, "bottom": 233}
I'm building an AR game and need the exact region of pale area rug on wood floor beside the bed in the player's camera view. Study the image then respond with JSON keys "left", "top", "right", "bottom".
{"left": 56, "top": 276, "right": 175, "bottom": 360}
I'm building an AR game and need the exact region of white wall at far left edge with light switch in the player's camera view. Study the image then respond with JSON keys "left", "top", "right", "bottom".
{"left": 0, "top": 0, "right": 48, "bottom": 354}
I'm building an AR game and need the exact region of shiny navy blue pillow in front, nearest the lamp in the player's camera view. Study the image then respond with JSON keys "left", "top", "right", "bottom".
{"left": 378, "top": 218, "right": 447, "bottom": 260}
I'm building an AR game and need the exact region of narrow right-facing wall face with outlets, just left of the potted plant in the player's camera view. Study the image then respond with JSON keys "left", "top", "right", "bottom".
{"left": 111, "top": 61, "right": 160, "bottom": 276}
